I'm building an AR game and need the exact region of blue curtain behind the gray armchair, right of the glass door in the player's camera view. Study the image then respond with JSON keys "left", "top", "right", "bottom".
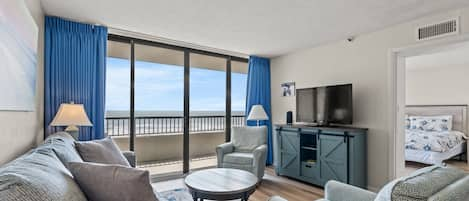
{"left": 246, "top": 56, "right": 273, "bottom": 165}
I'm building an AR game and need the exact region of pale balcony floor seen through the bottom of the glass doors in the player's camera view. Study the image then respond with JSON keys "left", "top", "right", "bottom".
{"left": 138, "top": 156, "right": 217, "bottom": 175}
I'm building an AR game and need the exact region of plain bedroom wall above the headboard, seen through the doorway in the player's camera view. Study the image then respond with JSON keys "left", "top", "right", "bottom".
{"left": 406, "top": 64, "right": 469, "bottom": 105}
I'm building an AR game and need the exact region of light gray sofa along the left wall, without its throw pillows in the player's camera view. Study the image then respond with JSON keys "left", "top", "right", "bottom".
{"left": 0, "top": 132, "right": 135, "bottom": 201}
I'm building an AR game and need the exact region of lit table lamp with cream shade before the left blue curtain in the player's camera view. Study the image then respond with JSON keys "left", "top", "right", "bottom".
{"left": 50, "top": 102, "right": 93, "bottom": 140}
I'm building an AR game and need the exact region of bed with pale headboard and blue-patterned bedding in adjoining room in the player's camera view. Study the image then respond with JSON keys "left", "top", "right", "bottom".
{"left": 405, "top": 105, "right": 468, "bottom": 165}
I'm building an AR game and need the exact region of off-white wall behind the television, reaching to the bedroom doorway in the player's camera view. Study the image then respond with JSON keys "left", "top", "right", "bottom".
{"left": 271, "top": 8, "right": 469, "bottom": 189}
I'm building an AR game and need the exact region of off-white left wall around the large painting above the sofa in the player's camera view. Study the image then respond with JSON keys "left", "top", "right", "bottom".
{"left": 0, "top": 0, "right": 44, "bottom": 165}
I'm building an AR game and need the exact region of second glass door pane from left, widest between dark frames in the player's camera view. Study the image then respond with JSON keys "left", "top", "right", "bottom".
{"left": 135, "top": 43, "right": 184, "bottom": 175}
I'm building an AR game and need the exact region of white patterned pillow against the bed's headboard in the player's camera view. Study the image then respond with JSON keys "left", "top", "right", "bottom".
{"left": 410, "top": 115, "right": 453, "bottom": 132}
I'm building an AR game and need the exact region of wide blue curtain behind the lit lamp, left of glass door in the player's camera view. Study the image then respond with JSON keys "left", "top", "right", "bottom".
{"left": 44, "top": 16, "right": 107, "bottom": 140}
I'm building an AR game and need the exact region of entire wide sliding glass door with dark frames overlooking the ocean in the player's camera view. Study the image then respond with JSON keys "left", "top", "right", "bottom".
{"left": 105, "top": 35, "right": 247, "bottom": 176}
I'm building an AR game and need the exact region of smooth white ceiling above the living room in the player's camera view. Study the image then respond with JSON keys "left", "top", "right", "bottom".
{"left": 41, "top": 0, "right": 469, "bottom": 57}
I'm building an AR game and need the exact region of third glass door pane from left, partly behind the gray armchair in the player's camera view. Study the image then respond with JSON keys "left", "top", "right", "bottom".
{"left": 189, "top": 53, "right": 227, "bottom": 170}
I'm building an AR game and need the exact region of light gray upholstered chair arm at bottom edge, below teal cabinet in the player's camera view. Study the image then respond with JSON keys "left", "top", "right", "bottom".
{"left": 324, "top": 180, "right": 376, "bottom": 201}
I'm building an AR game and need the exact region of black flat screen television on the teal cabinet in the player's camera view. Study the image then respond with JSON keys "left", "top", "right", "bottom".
{"left": 296, "top": 84, "right": 353, "bottom": 125}
